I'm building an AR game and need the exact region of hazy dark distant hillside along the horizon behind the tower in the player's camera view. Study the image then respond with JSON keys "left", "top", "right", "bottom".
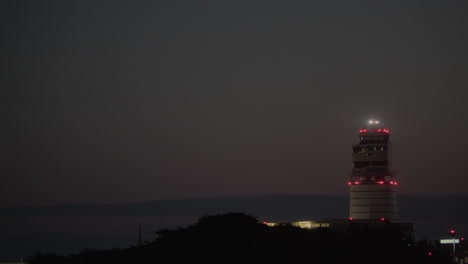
{"left": 0, "top": 195, "right": 468, "bottom": 262}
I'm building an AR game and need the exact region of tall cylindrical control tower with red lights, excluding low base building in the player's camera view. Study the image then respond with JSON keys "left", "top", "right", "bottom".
{"left": 348, "top": 120, "right": 398, "bottom": 220}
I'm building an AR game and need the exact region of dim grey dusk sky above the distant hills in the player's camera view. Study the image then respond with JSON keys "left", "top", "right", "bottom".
{"left": 0, "top": 0, "right": 468, "bottom": 205}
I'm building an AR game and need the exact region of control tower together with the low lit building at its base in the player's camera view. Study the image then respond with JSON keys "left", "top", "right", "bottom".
{"left": 263, "top": 120, "right": 415, "bottom": 241}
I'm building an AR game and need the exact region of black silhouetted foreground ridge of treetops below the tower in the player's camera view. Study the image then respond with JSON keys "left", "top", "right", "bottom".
{"left": 28, "top": 212, "right": 451, "bottom": 264}
